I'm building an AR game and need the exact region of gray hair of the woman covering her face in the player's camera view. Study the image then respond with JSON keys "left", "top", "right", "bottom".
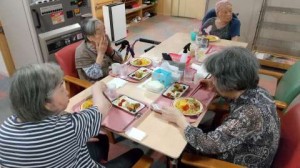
{"left": 81, "top": 18, "right": 103, "bottom": 41}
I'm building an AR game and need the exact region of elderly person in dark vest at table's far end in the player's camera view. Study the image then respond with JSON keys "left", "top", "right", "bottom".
{"left": 201, "top": 0, "right": 241, "bottom": 41}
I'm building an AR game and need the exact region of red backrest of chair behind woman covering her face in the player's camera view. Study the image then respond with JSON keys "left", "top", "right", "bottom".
{"left": 54, "top": 41, "right": 82, "bottom": 78}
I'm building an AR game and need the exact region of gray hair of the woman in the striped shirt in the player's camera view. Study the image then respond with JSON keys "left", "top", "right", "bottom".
{"left": 9, "top": 63, "right": 63, "bottom": 122}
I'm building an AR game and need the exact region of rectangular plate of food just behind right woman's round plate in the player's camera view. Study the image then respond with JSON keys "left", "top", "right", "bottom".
{"left": 162, "top": 82, "right": 189, "bottom": 99}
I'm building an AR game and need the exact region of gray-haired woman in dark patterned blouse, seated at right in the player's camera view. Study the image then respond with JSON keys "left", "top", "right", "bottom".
{"left": 162, "top": 47, "right": 280, "bottom": 167}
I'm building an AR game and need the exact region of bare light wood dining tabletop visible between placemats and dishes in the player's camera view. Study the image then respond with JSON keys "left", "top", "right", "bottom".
{"left": 66, "top": 33, "right": 247, "bottom": 167}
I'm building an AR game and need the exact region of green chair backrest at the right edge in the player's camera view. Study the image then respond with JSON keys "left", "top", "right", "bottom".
{"left": 274, "top": 61, "right": 300, "bottom": 107}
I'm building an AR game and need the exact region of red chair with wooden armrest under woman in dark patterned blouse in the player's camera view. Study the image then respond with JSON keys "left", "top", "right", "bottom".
{"left": 181, "top": 94, "right": 300, "bottom": 168}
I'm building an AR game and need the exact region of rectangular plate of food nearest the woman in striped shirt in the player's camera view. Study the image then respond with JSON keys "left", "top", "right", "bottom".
{"left": 112, "top": 95, "right": 146, "bottom": 114}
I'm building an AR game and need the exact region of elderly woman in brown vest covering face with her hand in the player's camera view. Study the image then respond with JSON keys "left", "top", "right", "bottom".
{"left": 75, "top": 18, "right": 123, "bottom": 82}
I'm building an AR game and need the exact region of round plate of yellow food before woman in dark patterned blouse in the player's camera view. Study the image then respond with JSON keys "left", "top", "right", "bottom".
{"left": 173, "top": 97, "right": 203, "bottom": 116}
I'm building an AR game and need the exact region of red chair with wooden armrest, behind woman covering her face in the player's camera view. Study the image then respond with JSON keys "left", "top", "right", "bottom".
{"left": 54, "top": 41, "right": 92, "bottom": 97}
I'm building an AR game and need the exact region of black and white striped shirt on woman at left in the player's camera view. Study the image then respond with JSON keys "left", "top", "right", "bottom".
{"left": 0, "top": 107, "right": 102, "bottom": 168}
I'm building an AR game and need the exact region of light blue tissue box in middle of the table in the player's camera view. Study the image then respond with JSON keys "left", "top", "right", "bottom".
{"left": 152, "top": 68, "right": 173, "bottom": 87}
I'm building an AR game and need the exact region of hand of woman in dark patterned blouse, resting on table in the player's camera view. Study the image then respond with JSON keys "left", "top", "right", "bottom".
{"left": 162, "top": 107, "right": 189, "bottom": 131}
